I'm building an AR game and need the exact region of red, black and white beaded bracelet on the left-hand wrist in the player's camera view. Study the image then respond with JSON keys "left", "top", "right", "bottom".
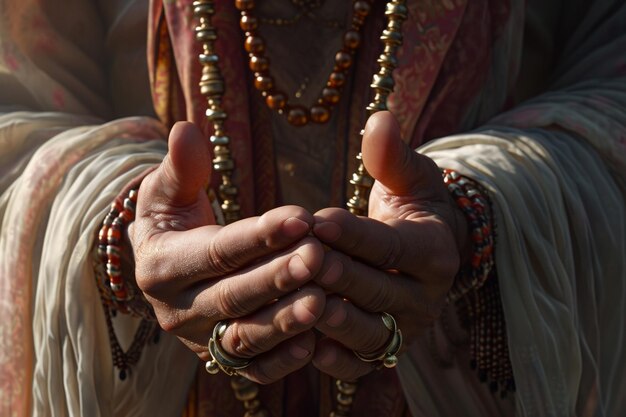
{"left": 94, "top": 187, "right": 159, "bottom": 380}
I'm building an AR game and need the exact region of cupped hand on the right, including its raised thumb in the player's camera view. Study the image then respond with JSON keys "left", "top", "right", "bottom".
{"left": 313, "top": 112, "right": 470, "bottom": 380}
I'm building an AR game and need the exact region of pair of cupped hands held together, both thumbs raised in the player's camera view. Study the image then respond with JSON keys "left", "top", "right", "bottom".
{"left": 129, "top": 112, "right": 468, "bottom": 384}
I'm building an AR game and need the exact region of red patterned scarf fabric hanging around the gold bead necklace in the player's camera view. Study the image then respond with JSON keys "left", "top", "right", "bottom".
{"left": 148, "top": 0, "right": 522, "bottom": 215}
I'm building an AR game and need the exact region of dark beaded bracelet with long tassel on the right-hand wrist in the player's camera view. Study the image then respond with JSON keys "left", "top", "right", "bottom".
{"left": 443, "top": 169, "right": 515, "bottom": 397}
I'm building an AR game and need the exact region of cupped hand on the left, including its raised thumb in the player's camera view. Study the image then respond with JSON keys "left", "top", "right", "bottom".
{"left": 129, "top": 123, "right": 325, "bottom": 383}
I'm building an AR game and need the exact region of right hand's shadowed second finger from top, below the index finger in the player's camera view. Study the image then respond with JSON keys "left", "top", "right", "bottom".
{"left": 315, "top": 245, "right": 445, "bottom": 316}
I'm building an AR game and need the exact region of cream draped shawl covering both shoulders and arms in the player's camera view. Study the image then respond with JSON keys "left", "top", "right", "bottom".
{"left": 0, "top": 0, "right": 626, "bottom": 416}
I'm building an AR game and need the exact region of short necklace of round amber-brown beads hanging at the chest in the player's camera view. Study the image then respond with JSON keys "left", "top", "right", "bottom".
{"left": 235, "top": 0, "right": 371, "bottom": 126}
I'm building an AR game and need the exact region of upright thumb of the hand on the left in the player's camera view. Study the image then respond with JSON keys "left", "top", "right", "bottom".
{"left": 150, "top": 122, "right": 211, "bottom": 207}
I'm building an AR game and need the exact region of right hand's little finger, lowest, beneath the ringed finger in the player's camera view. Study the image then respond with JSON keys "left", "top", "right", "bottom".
{"left": 313, "top": 338, "right": 377, "bottom": 381}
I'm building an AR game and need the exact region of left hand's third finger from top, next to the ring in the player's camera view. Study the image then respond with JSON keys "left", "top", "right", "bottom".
{"left": 220, "top": 285, "right": 326, "bottom": 358}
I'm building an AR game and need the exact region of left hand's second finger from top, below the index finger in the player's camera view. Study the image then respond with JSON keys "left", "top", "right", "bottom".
{"left": 146, "top": 238, "right": 324, "bottom": 338}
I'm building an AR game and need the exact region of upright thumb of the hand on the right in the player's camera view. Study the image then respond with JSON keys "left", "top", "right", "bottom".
{"left": 362, "top": 111, "right": 441, "bottom": 195}
